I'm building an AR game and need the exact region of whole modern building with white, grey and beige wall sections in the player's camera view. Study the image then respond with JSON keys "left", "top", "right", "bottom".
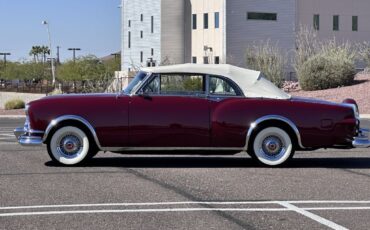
{"left": 122, "top": 0, "right": 370, "bottom": 73}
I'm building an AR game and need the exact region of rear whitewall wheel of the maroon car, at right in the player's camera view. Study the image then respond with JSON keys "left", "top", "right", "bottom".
{"left": 250, "top": 127, "right": 294, "bottom": 166}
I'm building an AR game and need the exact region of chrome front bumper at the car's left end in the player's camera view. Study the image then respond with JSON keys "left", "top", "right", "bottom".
{"left": 14, "top": 127, "right": 44, "bottom": 146}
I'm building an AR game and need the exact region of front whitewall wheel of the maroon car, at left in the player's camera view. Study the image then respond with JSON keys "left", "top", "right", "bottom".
{"left": 47, "top": 126, "right": 97, "bottom": 165}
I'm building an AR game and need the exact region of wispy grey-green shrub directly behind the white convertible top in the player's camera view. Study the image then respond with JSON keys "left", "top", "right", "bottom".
{"left": 246, "top": 41, "right": 285, "bottom": 88}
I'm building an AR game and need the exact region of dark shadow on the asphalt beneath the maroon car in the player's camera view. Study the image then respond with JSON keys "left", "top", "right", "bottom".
{"left": 45, "top": 156, "right": 370, "bottom": 169}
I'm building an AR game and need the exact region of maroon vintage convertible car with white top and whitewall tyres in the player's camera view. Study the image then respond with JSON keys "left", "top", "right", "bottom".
{"left": 14, "top": 64, "right": 370, "bottom": 166}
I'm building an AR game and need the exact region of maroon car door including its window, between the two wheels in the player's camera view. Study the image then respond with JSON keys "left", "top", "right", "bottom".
{"left": 129, "top": 73, "right": 210, "bottom": 149}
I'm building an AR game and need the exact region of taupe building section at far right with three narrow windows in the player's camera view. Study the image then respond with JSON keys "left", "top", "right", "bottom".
{"left": 297, "top": 0, "right": 370, "bottom": 42}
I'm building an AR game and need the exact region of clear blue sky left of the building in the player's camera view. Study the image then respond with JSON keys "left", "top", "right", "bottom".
{"left": 0, "top": 0, "right": 121, "bottom": 61}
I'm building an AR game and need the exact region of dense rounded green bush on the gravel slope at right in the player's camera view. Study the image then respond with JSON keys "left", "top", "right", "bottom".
{"left": 299, "top": 52, "right": 355, "bottom": 90}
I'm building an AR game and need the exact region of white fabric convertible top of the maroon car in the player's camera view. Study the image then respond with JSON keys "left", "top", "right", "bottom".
{"left": 142, "top": 64, "right": 291, "bottom": 99}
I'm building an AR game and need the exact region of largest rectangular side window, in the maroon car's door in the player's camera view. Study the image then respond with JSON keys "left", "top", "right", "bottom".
{"left": 160, "top": 74, "right": 205, "bottom": 95}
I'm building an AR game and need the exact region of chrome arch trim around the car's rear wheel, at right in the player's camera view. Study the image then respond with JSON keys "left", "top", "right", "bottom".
{"left": 244, "top": 115, "right": 305, "bottom": 151}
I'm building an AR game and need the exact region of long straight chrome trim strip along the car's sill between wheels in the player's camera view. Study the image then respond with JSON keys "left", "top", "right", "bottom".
{"left": 101, "top": 147, "right": 243, "bottom": 152}
